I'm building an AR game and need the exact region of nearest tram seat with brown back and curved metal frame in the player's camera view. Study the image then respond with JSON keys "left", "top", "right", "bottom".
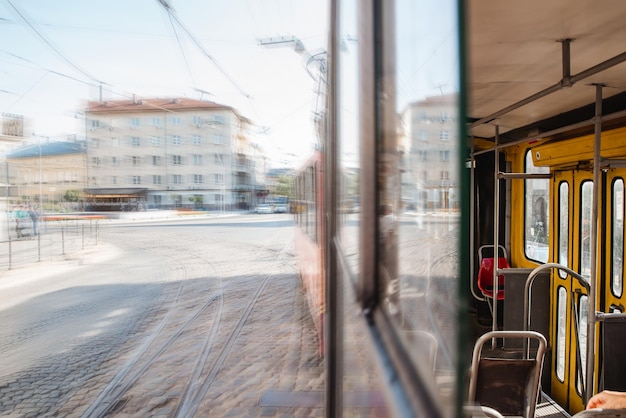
{"left": 468, "top": 331, "right": 547, "bottom": 418}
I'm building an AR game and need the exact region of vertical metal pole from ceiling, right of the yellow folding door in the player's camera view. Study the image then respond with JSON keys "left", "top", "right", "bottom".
{"left": 583, "top": 84, "right": 602, "bottom": 404}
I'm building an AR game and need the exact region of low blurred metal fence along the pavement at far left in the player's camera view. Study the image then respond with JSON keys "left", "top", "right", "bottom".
{"left": 0, "top": 219, "right": 100, "bottom": 273}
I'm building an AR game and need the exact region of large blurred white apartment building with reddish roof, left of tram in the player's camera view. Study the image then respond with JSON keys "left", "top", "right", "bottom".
{"left": 85, "top": 98, "right": 266, "bottom": 210}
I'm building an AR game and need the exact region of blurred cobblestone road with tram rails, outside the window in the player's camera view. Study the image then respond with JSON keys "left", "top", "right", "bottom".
{"left": 0, "top": 215, "right": 321, "bottom": 417}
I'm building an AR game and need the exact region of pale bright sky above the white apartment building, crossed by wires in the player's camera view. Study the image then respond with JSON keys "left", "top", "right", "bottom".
{"left": 0, "top": 0, "right": 328, "bottom": 166}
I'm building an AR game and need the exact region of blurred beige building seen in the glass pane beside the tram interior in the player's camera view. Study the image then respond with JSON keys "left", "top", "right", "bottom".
{"left": 400, "top": 95, "right": 459, "bottom": 212}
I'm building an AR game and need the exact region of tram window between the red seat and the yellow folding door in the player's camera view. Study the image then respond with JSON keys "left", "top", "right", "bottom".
{"left": 524, "top": 150, "right": 550, "bottom": 263}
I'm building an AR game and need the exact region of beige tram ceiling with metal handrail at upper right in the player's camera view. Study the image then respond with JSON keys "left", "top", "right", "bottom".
{"left": 467, "top": 0, "right": 626, "bottom": 143}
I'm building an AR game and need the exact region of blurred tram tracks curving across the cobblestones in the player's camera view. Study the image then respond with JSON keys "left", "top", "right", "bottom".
{"left": 82, "top": 224, "right": 287, "bottom": 418}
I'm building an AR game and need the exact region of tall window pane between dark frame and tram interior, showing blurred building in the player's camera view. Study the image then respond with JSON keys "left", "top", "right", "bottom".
{"left": 377, "top": 0, "right": 461, "bottom": 416}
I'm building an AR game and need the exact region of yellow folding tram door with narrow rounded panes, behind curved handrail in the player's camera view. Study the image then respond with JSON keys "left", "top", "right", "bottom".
{"left": 550, "top": 171, "right": 594, "bottom": 412}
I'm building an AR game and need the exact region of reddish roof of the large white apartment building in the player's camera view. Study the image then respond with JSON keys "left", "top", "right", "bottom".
{"left": 87, "top": 98, "right": 234, "bottom": 113}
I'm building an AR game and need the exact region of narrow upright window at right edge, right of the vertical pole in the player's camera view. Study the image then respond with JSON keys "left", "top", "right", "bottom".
{"left": 611, "top": 179, "right": 624, "bottom": 297}
